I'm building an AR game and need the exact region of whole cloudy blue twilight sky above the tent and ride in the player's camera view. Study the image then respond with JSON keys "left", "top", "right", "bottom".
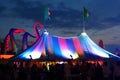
{"left": 0, "top": 0, "right": 120, "bottom": 50}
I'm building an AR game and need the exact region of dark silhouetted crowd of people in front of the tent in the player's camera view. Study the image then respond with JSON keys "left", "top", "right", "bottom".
{"left": 0, "top": 61, "right": 120, "bottom": 80}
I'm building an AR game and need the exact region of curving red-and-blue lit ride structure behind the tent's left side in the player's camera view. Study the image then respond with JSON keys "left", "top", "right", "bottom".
{"left": 4, "top": 22, "right": 43, "bottom": 54}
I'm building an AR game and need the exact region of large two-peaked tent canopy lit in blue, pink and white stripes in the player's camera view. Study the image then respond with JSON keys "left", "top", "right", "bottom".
{"left": 11, "top": 31, "right": 119, "bottom": 60}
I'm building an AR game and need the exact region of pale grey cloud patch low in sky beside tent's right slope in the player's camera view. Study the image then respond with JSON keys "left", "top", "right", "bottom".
{"left": 87, "top": 25, "right": 120, "bottom": 45}
